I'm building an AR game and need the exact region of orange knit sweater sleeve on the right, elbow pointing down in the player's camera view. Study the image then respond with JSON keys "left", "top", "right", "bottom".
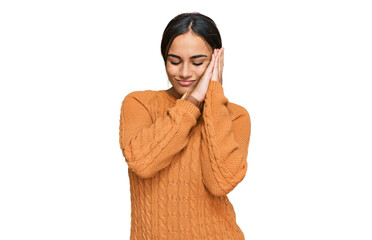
{"left": 201, "top": 81, "right": 251, "bottom": 196}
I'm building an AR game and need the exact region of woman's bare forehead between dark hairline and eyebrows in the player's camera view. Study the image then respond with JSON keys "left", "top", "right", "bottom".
{"left": 169, "top": 31, "right": 212, "bottom": 55}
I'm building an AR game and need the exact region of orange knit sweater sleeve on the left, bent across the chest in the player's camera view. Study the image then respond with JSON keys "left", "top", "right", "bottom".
{"left": 119, "top": 92, "right": 201, "bottom": 178}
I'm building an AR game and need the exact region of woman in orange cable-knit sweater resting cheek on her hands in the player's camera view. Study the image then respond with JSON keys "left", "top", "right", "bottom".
{"left": 120, "top": 13, "right": 251, "bottom": 239}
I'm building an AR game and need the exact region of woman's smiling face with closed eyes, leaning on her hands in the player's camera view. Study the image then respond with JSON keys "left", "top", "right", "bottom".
{"left": 166, "top": 31, "right": 213, "bottom": 98}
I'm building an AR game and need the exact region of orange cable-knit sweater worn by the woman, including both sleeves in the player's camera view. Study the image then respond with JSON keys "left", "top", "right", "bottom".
{"left": 119, "top": 81, "right": 251, "bottom": 240}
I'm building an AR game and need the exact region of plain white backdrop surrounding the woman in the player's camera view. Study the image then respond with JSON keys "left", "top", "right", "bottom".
{"left": 0, "top": 0, "right": 372, "bottom": 240}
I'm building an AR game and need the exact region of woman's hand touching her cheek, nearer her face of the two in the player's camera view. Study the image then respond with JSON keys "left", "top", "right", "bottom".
{"left": 191, "top": 49, "right": 221, "bottom": 102}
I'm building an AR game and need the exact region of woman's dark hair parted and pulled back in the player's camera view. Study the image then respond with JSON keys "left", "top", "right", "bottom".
{"left": 161, "top": 12, "right": 222, "bottom": 62}
